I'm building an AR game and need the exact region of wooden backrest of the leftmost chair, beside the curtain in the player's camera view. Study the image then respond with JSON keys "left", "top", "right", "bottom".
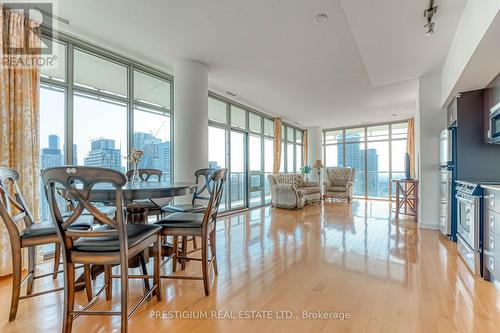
{"left": 0, "top": 167, "right": 34, "bottom": 244}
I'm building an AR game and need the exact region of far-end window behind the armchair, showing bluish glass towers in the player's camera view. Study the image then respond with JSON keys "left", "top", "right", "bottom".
{"left": 323, "top": 122, "right": 407, "bottom": 199}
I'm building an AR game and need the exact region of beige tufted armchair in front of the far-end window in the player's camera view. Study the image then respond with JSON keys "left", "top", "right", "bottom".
{"left": 324, "top": 167, "right": 356, "bottom": 202}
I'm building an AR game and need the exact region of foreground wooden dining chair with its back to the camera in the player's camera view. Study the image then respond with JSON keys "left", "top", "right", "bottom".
{"left": 42, "top": 166, "right": 162, "bottom": 333}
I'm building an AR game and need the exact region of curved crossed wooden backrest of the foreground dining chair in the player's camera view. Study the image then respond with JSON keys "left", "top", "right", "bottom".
{"left": 42, "top": 166, "right": 127, "bottom": 251}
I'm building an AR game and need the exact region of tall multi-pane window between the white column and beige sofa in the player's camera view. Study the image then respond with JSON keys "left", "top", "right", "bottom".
{"left": 208, "top": 94, "right": 282, "bottom": 210}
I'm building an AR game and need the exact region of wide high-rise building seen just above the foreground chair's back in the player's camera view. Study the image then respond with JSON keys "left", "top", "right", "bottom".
{"left": 84, "top": 138, "right": 125, "bottom": 172}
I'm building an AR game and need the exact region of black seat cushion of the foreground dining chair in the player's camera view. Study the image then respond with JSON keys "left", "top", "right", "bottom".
{"left": 74, "top": 224, "right": 161, "bottom": 252}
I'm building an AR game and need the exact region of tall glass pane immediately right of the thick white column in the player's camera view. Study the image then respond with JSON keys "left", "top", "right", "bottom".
{"left": 208, "top": 126, "right": 228, "bottom": 210}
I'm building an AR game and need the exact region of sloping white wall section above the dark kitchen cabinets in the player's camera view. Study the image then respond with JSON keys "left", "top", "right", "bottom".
{"left": 438, "top": 0, "right": 500, "bottom": 106}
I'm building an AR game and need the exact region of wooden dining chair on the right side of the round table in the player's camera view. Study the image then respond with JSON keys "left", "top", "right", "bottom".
{"left": 156, "top": 169, "right": 227, "bottom": 296}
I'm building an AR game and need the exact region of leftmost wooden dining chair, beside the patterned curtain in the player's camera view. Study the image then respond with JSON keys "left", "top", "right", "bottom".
{"left": 0, "top": 167, "right": 92, "bottom": 321}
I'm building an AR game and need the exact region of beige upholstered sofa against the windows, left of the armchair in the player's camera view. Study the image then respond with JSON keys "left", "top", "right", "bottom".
{"left": 267, "top": 173, "right": 321, "bottom": 209}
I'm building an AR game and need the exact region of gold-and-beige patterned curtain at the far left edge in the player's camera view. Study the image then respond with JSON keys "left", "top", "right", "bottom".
{"left": 0, "top": 7, "right": 40, "bottom": 275}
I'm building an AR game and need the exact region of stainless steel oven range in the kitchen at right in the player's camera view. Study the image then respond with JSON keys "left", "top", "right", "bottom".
{"left": 455, "top": 181, "right": 482, "bottom": 276}
